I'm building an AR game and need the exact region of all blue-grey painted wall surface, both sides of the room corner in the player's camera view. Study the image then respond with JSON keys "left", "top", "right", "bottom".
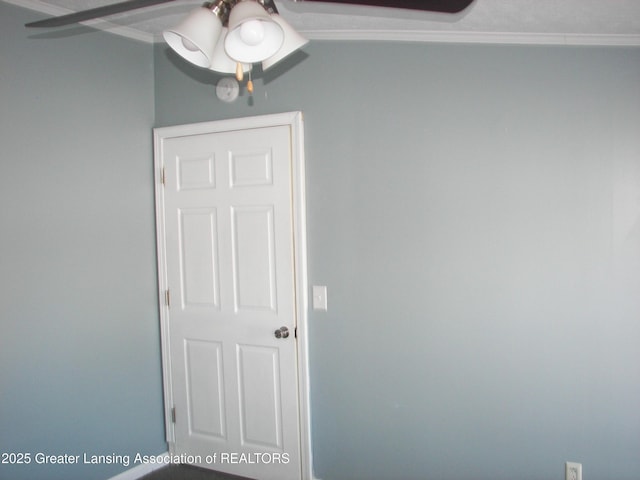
{"left": 0, "top": 3, "right": 640, "bottom": 480}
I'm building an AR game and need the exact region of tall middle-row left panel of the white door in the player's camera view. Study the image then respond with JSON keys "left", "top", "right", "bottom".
{"left": 178, "top": 208, "right": 220, "bottom": 309}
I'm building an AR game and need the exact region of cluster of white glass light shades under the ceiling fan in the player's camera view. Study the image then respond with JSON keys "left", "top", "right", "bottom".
{"left": 163, "top": 0, "right": 309, "bottom": 87}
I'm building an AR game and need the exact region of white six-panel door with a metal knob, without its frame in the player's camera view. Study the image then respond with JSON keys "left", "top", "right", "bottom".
{"left": 156, "top": 116, "right": 301, "bottom": 480}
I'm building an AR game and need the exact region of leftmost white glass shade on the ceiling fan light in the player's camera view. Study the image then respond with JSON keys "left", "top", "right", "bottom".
{"left": 162, "top": 7, "right": 222, "bottom": 68}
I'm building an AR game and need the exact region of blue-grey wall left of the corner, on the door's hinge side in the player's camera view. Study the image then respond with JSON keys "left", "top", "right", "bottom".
{"left": 0, "top": 2, "right": 167, "bottom": 480}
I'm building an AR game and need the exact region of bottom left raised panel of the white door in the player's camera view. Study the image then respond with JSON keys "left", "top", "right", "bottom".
{"left": 184, "top": 339, "right": 226, "bottom": 438}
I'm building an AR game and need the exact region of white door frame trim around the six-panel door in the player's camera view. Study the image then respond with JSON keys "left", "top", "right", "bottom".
{"left": 153, "top": 112, "right": 313, "bottom": 480}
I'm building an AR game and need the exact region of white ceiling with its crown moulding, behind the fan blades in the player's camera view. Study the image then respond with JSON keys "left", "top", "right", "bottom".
{"left": 4, "top": 0, "right": 640, "bottom": 46}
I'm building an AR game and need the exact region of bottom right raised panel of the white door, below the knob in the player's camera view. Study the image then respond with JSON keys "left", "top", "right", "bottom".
{"left": 237, "top": 345, "right": 282, "bottom": 449}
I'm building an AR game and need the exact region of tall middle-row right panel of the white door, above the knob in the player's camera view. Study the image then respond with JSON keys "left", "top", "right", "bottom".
{"left": 232, "top": 205, "right": 276, "bottom": 311}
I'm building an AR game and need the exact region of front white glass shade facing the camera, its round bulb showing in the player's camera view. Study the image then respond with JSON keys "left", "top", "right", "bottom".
{"left": 224, "top": 0, "right": 284, "bottom": 63}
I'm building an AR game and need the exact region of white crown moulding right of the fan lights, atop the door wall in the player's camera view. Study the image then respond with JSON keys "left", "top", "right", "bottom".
{"left": 300, "top": 30, "right": 640, "bottom": 47}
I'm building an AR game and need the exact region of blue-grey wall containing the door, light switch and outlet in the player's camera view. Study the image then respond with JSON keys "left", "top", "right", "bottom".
{"left": 155, "top": 42, "right": 640, "bottom": 480}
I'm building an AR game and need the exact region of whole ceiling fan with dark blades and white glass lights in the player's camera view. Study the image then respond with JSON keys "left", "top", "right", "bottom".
{"left": 26, "top": 0, "right": 474, "bottom": 87}
